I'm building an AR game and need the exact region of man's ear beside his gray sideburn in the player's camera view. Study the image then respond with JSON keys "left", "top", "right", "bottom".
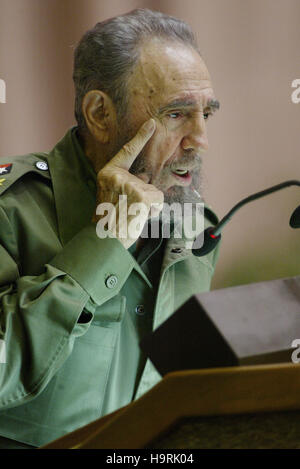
{"left": 82, "top": 90, "right": 116, "bottom": 143}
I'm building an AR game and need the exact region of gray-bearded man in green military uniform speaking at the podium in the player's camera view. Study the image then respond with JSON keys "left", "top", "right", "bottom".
{"left": 0, "top": 10, "right": 218, "bottom": 448}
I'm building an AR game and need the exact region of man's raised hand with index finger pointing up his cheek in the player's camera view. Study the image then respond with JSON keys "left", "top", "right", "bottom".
{"left": 93, "top": 119, "right": 164, "bottom": 249}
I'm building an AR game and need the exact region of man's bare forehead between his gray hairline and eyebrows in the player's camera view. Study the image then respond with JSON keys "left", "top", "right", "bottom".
{"left": 130, "top": 44, "right": 217, "bottom": 118}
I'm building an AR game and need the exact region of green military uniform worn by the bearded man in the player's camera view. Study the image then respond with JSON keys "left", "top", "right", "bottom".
{"left": 0, "top": 128, "right": 217, "bottom": 446}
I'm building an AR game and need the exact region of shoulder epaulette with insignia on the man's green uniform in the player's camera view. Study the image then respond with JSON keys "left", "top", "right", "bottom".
{"left": 0, "top": 153, "right": 51, "bottom": 196}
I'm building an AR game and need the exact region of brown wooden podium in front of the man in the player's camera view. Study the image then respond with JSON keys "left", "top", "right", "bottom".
{"left": 40, "top": 363, "right": 300, "bottom": 449}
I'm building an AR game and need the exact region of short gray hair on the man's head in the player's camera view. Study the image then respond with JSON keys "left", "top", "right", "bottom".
{"left": 73, "top": 9, "right": 199, "bottom": 131}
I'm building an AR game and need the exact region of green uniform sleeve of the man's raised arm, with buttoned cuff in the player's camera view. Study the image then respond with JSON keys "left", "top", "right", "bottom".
{"left": 0, "top": 207, "right": 134, "bottom": 409}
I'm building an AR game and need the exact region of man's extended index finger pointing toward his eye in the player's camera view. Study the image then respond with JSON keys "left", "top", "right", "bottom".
{"left": 106, "top": 119, "right": 156, "bottom": 171}
